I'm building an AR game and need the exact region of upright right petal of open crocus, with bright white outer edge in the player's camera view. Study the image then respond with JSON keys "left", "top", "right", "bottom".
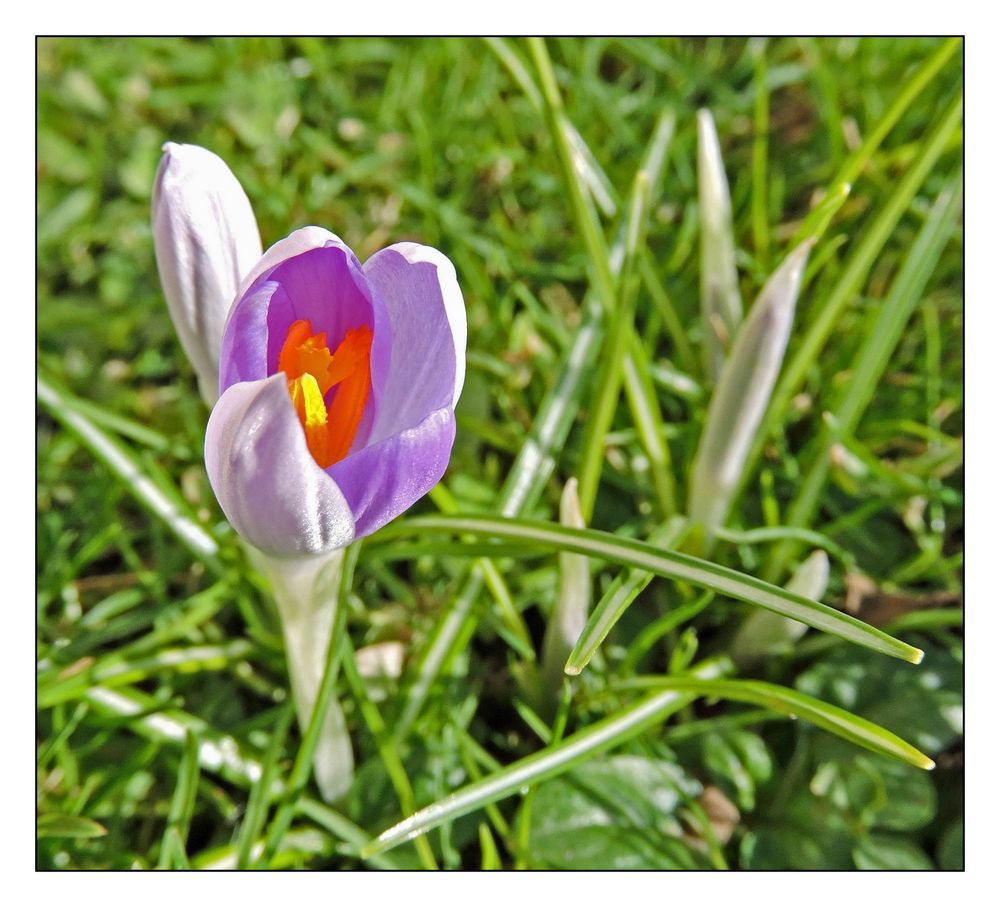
{"left": 364, "top": 243, "right": 467, "bottom": 444}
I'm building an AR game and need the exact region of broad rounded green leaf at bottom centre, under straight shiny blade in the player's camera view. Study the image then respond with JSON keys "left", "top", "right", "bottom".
{"left": 530, "top": 756, "right": 708, "bottom": 870}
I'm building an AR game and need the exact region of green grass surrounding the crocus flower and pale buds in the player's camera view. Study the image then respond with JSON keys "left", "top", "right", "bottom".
{"left": 36, "top": 38, "right": 964, "bottom": 869}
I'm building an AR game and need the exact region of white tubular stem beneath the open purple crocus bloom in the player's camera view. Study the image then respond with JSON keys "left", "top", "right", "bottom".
{"left": 253, "top": 550, "right": 354, "bottom": 803}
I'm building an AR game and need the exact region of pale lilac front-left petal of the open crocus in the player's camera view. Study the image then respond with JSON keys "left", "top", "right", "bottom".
{"left": 205, "top": 374, "right": 355, "bottom": 557}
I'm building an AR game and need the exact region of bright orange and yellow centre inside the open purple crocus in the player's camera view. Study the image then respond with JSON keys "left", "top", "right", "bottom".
{"left": 278, "top": 320, "right": 372, "bottom": 469}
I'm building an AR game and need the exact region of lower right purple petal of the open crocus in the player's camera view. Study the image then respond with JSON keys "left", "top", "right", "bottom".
{"left": 327, "top": 406, "right": 455, "bottom": 538}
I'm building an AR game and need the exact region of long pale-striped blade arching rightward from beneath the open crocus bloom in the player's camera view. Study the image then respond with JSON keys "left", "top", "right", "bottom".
{"left": 382, "top": 516, "right": 923, "bottom": 664}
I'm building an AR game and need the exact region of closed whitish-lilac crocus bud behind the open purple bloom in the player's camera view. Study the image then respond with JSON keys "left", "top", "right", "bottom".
{"left": 153, "top": 142, "right": 261, "bottom": 404}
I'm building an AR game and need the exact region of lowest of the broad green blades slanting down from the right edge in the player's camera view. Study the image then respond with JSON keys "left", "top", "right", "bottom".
{"left": 765, "top": 172, "right": 962, "bottom": 579}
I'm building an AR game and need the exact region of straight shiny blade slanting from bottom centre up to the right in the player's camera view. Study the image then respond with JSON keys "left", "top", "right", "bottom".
{"left": 362, "top": 665, "right": 719, "bottom": 856}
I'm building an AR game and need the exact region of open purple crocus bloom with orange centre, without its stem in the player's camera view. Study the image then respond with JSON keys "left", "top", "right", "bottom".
{"left": 205, "top": 227, "right": 466, "bottom": 557}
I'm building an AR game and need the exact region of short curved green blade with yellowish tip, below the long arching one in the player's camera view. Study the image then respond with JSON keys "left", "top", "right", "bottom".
{"left": 614, "top": 677, "right": 934, "bottom": 770}
